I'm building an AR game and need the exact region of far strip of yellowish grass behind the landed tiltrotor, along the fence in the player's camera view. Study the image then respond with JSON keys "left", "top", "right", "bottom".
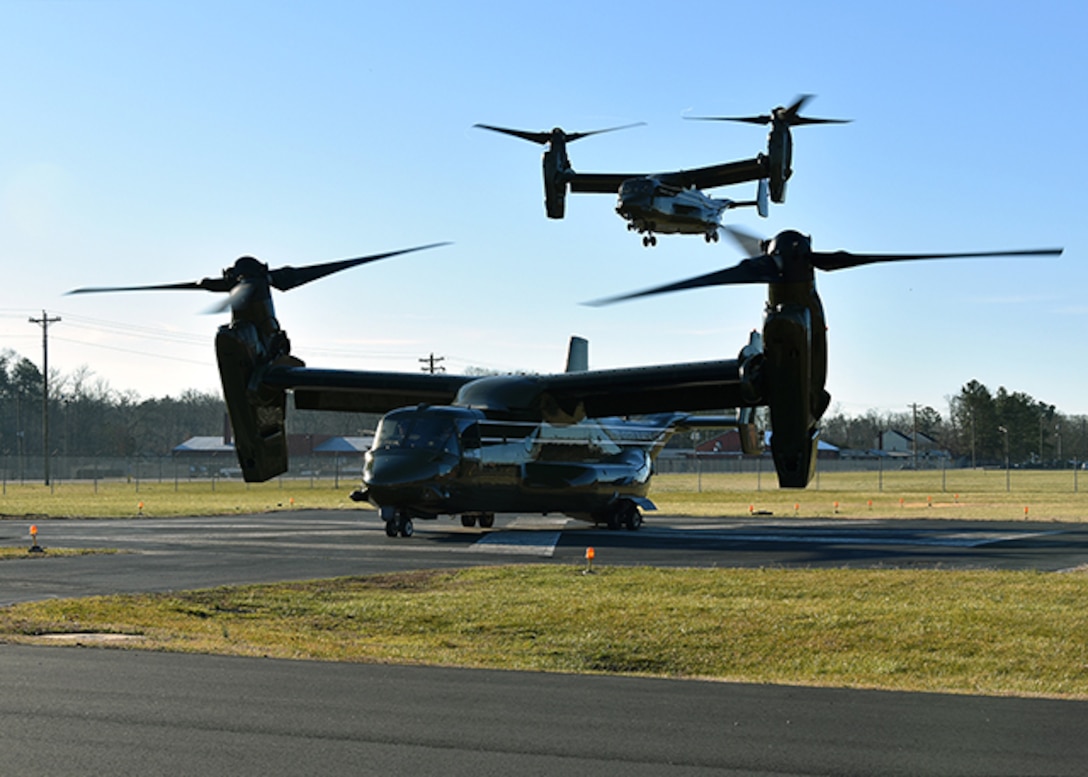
{"left": 0, "top": 470, "right": 1088, "bottom": 521}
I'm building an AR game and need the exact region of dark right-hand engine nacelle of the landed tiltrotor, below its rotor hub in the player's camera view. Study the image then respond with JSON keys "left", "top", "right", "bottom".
{"left": 763, "top": 304, "right": 819, "bottom": 489}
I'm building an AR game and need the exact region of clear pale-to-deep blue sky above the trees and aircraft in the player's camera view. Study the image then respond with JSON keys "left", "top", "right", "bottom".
{"left": 0, "top": 0, "right": 1088, "bottom": 415}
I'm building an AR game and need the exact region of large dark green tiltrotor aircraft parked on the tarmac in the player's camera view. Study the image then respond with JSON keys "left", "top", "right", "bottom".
{"left": 74, "top": 231, "right": 1061, "bottom": 537}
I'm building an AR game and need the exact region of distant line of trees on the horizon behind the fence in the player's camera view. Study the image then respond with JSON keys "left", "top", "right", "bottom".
{"left": 0, "top": 349, "right": 1088, "bottom": 466}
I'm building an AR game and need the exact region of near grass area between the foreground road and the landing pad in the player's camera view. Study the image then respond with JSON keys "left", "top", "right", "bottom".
{"left": 0, "top": 566, "right": 1088, "bottom": 699}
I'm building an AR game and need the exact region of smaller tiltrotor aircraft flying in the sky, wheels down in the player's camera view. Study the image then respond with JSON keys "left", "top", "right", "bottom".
{"left": 475, "top": 95, "right": 848, "bottom": 246}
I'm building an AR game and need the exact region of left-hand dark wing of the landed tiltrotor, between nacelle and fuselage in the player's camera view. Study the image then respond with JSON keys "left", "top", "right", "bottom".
{"left": 261, "top": 367, "right": 474, "bottom": 412}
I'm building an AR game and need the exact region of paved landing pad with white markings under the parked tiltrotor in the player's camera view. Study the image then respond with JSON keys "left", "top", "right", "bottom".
{"left": 0, "top": 510, "right": 1088, "bottom": 605}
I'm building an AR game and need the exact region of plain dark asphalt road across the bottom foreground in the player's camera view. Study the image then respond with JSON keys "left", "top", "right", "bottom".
{"left": 6, "top": 645, "right": 1088, "bottom": 777}
